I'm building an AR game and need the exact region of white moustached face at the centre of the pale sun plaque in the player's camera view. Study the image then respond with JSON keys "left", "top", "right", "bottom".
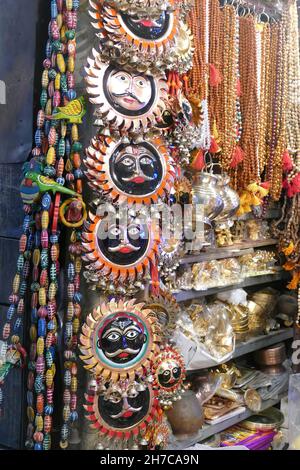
{"left": 107, "top": 69, "right": 153, "bottom": 114}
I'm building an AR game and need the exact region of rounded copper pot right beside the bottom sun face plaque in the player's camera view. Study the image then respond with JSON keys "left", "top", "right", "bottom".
{"left": 166, "top": 390, "right": 204, "bottom": 440}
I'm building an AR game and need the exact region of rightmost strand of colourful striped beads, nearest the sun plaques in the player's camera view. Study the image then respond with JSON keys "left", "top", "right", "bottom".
{"left": 60, "top": 0, "right": 83, "bottom": 449}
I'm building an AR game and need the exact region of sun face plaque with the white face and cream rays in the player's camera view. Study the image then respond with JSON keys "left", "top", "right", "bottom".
{"left": 86, "top": 49, "right": 168, "bottom": 132}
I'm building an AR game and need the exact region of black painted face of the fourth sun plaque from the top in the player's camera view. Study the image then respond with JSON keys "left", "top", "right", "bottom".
{"left": 97, "top": 218, "right": 149, "bottom": 266}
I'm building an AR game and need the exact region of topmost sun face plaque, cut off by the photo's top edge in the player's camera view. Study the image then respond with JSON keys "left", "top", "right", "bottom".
{"left": 89, "top": 1, "right": 180, "bottom": 71}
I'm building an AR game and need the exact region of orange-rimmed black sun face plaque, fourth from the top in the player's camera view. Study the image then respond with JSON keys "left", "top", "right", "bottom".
{"left": 82, "top": 207, "right": 159, "bottom": 282}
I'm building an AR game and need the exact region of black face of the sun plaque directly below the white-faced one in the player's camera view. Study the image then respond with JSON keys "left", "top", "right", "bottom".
{"left": 110, "top": 142, "right": 163, "bottom": 196}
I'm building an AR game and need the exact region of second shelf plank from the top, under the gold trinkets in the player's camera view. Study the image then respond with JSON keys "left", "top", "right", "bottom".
{"left": 174, "top": 271, "right": 289, "bottom": 302}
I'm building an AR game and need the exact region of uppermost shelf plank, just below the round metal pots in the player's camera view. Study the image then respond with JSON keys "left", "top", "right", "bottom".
{"left": 180, "top": 238, "right": 278, "bottom": 264}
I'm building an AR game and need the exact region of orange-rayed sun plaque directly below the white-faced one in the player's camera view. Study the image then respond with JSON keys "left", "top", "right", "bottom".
{"left": 85, "top": 136, "right": 175, "bottom": 205}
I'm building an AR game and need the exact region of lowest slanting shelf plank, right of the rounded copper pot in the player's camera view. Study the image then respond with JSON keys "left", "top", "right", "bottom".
{"left": 169, "top": 392, "right": 286, "bottom": 450}
